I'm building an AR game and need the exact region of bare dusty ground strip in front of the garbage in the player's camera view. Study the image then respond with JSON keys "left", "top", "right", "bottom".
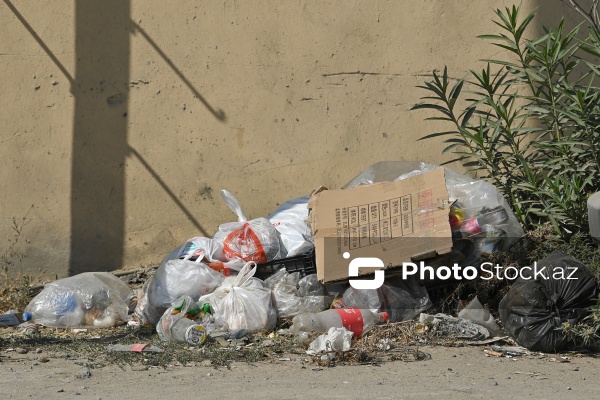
{"left": 0, "top": 346, "right": 600, "bottom": 400}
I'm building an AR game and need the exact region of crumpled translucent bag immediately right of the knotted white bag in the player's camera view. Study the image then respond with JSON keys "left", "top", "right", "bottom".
{"left": 265, "top": 268, "right": 332, "bottom": 318}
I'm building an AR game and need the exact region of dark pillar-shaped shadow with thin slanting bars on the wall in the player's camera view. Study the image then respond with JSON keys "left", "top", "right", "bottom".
{"left": 3, "top": 0, "right": 226, "bottom": 275}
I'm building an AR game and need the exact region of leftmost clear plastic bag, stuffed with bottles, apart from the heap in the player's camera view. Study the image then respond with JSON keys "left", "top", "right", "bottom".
{"left": 25, "top": 272, "right": 133, "bottom": 328}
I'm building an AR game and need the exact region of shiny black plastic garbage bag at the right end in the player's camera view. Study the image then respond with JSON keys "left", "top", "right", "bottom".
{"left": 499, "top": 251, "right": 598, "bottom": 352}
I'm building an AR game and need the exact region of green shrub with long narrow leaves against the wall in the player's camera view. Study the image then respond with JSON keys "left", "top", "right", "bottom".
{"left": 412, "top": 6, "right": 600, "bottom": 238}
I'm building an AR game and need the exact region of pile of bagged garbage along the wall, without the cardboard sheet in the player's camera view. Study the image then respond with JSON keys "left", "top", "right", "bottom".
{"left": 0, "top": 162, "right": 598, "bottom": 357}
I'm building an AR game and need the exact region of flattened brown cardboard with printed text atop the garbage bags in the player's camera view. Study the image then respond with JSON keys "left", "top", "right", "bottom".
{"left": 308, "top": 168, "right": 452, "bottom": 283}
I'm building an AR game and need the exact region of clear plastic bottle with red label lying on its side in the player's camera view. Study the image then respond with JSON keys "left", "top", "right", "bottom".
{"left": 290, "top": 308, "right": 389, "bottom": 337}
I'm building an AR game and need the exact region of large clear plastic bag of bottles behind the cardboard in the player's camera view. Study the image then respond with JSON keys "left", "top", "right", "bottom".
{"left": 344, "top": 161, "right": 523, "bottom": 252}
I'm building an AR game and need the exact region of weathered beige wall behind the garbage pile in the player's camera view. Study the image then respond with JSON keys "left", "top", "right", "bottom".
{"left": 0, "top": 0, "right": 574, "bottom": 277}
